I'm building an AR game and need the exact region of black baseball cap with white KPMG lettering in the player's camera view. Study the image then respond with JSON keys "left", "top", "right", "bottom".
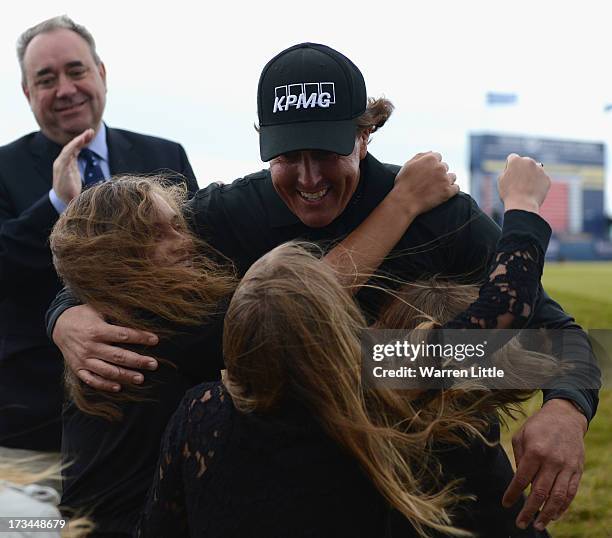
{"left": 257, "top": 43, "right": 367, "bottom": 161}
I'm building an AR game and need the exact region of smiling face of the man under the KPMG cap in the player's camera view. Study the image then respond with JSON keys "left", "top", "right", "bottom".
{"left": 270, "top": 134, "right": 368, "bottom": 228}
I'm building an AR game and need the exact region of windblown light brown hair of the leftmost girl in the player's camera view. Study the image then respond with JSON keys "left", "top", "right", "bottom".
{"left": 50, "top": 176, "right": 236, "bottom": 418}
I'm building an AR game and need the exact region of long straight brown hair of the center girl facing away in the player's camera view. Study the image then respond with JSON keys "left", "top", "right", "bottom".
{"left": 223, "top": 243, "right": 469, "bottom": 536}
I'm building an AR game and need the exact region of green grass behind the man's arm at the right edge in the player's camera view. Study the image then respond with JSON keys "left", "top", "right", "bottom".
{"left": 503, "top": 263, "right": 612, "bottom": 538}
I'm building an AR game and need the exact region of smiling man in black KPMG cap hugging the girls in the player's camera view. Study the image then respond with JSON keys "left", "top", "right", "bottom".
{"left": 48, "top": 43, "right": 598, "bottom": 527}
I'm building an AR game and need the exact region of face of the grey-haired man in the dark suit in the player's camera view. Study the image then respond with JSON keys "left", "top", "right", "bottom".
{"left": 23, "top": 29, "right": 106, "bottom": 145}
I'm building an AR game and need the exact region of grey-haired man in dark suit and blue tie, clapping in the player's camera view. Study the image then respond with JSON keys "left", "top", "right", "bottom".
{"left": 0, "top": 16, "right": 197, "bottom": 457}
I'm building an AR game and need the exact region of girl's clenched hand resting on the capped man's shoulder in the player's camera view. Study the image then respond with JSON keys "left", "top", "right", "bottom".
{"left": 390, "top": 151, "right": 459, "bottom": 215}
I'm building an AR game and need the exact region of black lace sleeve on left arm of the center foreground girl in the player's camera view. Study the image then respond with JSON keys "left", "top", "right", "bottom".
{"left": 136, "top": 383, "right": 228, "bottom": 538}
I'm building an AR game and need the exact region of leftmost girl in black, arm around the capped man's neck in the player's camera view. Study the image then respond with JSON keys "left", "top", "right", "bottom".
{"left": 51, "top": 169, "right": 455, "bottom": 537}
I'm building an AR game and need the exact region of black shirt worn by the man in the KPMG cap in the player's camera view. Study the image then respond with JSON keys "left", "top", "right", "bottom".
{"left": 186, "top": 153, "right": 598, "bottom": 420}
